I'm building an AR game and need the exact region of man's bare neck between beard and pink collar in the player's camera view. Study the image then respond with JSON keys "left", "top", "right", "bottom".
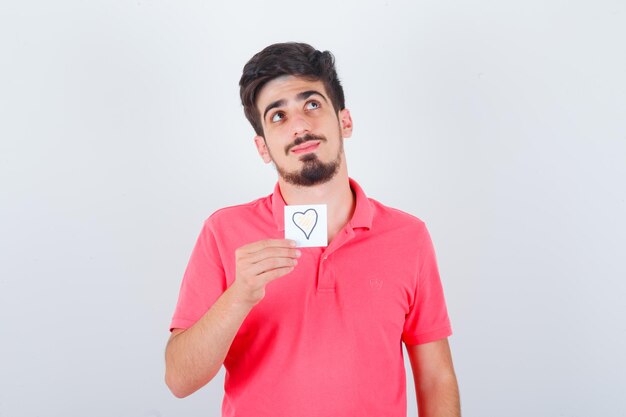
{"left": 278, "top": 170, "right": 356, "bottom": 243}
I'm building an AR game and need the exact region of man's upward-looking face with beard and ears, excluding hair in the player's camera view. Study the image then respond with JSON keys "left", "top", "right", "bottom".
{"left": 254, "top": 76, "right": 352, "bottom": 186}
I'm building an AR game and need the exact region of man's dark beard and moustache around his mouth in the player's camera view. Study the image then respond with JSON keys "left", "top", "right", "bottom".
{"left": 274, "top": 135, "right": 343, "bottom": 187}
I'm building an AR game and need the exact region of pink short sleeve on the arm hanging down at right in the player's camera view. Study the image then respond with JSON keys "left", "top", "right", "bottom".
{"left": 402, "top": 226, "right": 452, "bottom": 345}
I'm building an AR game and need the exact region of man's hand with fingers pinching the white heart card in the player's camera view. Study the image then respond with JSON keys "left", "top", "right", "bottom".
{"left": 230, "top": 239, "right": 301, "bottom": 306}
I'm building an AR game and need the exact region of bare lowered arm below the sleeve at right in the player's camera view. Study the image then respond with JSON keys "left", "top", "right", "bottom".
{"left": 406, "top": 339, "right": 461, "bottom": 417}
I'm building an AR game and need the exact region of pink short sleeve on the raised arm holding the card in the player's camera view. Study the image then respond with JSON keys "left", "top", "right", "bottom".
{"left": 170, "top": 217, "right": 226, "bottom": 330}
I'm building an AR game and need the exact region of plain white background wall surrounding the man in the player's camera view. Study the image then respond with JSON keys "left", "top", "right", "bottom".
{"left": 0, "top": 0, "right": 626, "bottom": 417}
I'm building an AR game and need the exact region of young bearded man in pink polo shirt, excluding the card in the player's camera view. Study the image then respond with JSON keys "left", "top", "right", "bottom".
{"left": 166, "top": 43, "right": 460, "bottom": 417}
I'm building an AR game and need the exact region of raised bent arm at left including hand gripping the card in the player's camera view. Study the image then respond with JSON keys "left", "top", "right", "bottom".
{"left": 165, "top": 239, "right": 300, "bottom": 398}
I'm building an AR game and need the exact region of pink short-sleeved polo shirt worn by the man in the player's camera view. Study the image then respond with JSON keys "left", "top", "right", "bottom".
{"left": 171, "top": 179, "right": 451, "bottom": 417}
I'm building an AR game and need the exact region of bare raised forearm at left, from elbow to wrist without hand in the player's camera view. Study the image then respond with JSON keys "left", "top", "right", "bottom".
{"left": 165, "top": 289, "right": 252, "bottom": 398}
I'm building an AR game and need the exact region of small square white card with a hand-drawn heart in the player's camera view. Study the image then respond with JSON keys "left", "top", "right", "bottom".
{"left": 285, "top": 204, "right": 328, "bottom": 248}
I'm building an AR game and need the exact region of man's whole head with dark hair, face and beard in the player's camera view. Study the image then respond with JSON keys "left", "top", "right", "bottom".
{"left": 240, "top": 43, "right": 352, "bottom": 186}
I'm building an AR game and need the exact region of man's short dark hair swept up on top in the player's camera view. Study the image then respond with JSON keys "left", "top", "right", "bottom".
{"left": 239, "top": 42, "right": 346, "bottom": 136}
